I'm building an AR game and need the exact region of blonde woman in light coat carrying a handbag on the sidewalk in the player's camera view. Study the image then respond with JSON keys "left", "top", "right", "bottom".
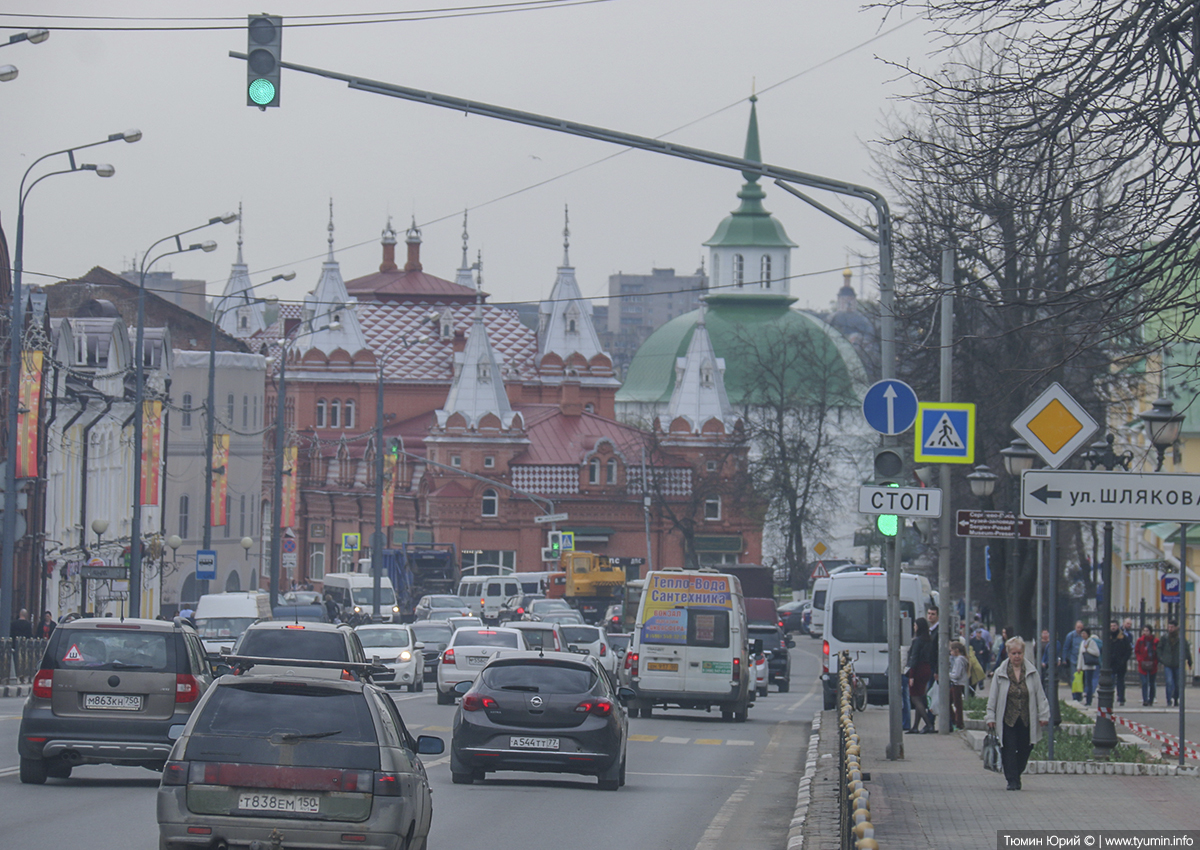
{"left": 984, "top": 636, "right": 1050, "bottom": 791}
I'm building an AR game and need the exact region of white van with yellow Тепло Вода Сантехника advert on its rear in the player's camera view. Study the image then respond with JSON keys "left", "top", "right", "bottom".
{"left": 626, "top": 569, "right": 754, "bottom": 722}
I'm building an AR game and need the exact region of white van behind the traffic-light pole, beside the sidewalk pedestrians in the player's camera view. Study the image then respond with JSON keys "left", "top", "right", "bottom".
{"left": 821, "top": 569, "right": 931, "bottom": 710}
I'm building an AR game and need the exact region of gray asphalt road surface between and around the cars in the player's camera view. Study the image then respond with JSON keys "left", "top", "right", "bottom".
{"left": 0, "top": 635, "right": 821, "bottom": 850}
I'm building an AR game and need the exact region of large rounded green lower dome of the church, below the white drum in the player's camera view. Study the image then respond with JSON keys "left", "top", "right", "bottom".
{"left": 616, "top": 293, "right": 866, "bottom": 406}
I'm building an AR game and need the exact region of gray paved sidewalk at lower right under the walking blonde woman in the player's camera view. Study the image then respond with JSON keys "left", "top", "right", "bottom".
{"left": 805, "top": 706, "right": 1200, "bottom": 850}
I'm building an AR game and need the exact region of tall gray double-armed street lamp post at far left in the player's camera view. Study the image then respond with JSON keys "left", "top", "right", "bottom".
{"left": 0, "top": 129, "right": 142, "bottom": 635}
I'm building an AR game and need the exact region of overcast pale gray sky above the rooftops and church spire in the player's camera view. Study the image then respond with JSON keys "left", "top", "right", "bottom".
{"left": 0, "top": 0, "right": 934, "bottom": 319}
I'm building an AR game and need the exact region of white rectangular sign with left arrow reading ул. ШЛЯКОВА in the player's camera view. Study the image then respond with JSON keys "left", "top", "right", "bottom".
{"left": 1021, "top": 469, "right": 1200, "bottom": 522}
